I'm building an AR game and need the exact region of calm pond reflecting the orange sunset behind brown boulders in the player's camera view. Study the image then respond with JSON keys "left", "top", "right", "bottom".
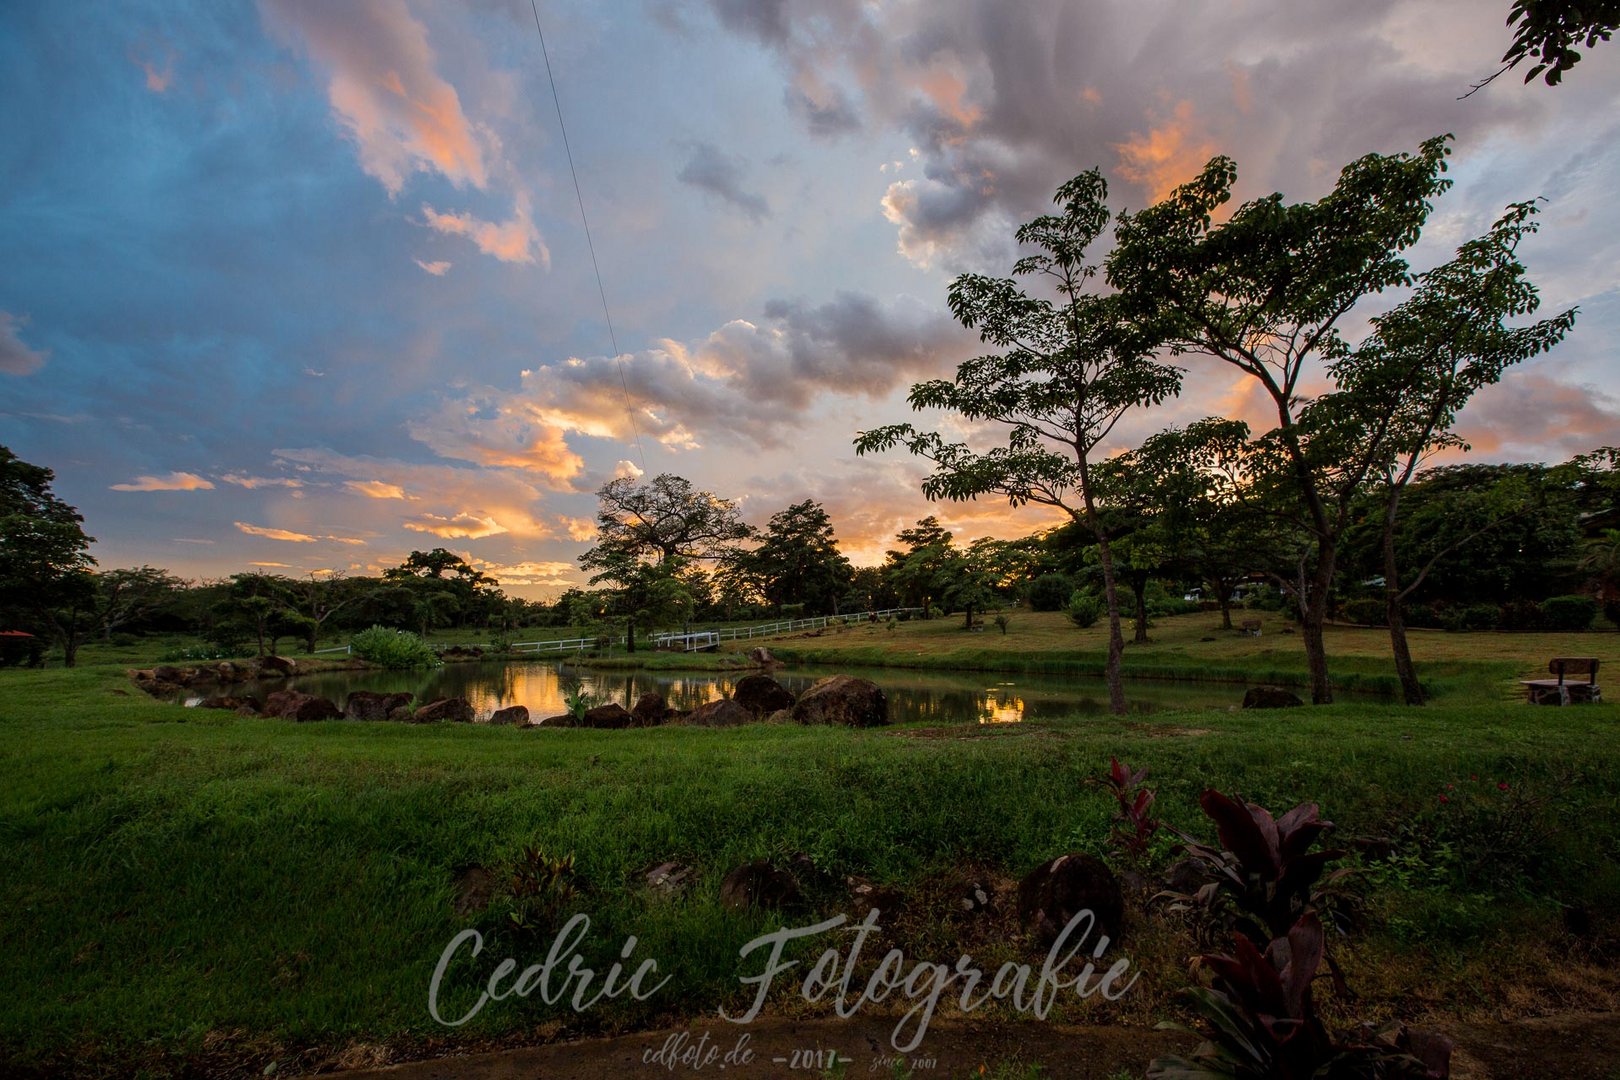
{"left": 188, "top": 661, "right": 1276, "bottom": 724}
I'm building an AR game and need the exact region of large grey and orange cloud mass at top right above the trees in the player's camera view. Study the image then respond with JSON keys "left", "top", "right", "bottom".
{"left": 711, "top": 0, "right": 1549, "bottom": 270}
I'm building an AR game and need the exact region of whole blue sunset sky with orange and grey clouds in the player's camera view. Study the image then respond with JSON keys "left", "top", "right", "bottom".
{"left": 0, "top": 0, "right": 1620, "bottom": 596}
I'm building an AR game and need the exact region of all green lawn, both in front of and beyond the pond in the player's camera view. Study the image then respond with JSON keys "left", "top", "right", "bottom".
{"left": 0, "top": 614, "right": 1620, "bottom": 1075}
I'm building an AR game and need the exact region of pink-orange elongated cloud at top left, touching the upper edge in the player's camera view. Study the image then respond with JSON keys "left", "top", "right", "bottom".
{"left": 261, "top": 0, "right": 489, "bottom": 196}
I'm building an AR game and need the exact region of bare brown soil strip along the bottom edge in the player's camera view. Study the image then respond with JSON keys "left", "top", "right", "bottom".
{"left": 329, "top": 1012, "right": 1620, "bottom": 1080}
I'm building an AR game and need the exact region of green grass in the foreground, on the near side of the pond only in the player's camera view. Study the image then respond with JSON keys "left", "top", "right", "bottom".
{"left": 0, "top": 660, "right": 1620, "bottom": 1065}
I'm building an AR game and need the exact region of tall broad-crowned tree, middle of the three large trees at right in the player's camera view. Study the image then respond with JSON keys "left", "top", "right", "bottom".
{"left": 1108, "top": 136, "right": 1450, "bottom": 704}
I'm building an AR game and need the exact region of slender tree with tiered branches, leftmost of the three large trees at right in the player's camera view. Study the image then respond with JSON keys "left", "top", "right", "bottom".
{"left": 855, "top": 170, "right": 1181, "bottom": 714}
